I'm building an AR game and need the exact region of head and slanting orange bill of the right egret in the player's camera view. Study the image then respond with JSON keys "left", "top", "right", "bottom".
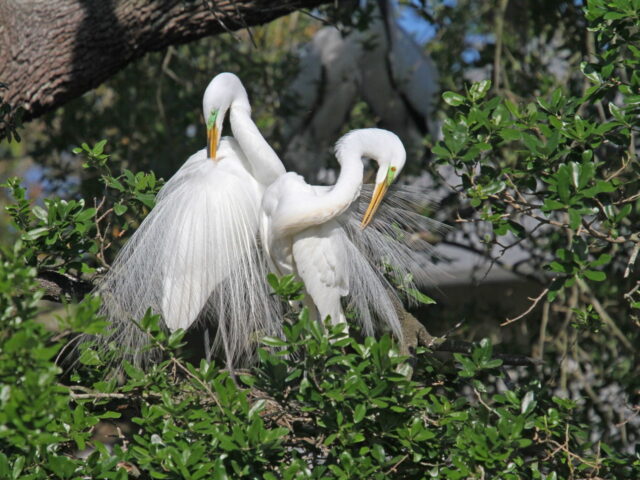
{"left": 357, "top": 128, "right": 407, "bottom": 228}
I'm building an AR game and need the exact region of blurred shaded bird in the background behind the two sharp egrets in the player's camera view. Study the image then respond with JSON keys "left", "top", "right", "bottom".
{"left": 283, "top": 0, "right": 440, "bottom": 181}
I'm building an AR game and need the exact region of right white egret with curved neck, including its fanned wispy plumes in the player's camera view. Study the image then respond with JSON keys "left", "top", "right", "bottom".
{"left": 262, "top": 129, "right": 448, "bottom": 344}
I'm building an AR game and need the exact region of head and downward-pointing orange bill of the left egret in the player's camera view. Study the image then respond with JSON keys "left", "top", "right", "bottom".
{"left": 202, "top": 72, "right": 251, "bottom": 159}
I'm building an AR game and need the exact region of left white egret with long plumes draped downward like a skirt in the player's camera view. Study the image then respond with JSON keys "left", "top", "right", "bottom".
{"left": 98, "top": 73, "right": 285, "bottom": 364}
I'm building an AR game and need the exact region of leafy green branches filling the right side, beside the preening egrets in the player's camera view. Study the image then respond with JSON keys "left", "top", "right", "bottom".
{"left": 433, "top": 1, "right": 640, "bottom": 454}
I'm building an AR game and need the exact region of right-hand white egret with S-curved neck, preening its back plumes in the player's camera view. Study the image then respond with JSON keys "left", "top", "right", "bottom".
{"left": 262, "top": 128, "right": 436, "bottom": 338}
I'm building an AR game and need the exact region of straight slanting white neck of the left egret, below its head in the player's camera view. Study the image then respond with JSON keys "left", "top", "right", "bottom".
{"left": 230, "top": 105, "right": 286, "bottom": 186}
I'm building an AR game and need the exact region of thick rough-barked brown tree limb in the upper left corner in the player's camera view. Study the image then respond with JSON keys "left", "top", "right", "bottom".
{"left": 0, "top": 0, "right": 328, "bottom": 119}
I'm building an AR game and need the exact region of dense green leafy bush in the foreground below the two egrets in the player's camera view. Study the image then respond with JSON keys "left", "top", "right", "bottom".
{"left": 0, "top": 248, "right": 640, "bottom": 479}
